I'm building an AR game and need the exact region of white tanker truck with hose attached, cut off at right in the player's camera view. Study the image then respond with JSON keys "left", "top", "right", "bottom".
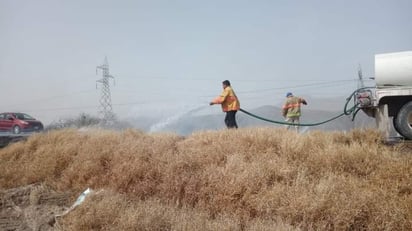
{"left": 355, "top": 51, "right": 412, "bottom": 140}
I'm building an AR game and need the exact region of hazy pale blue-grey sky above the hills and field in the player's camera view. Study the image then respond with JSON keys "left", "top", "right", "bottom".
{"left": 0, "top": 0, "right": 412, "bottom": 123}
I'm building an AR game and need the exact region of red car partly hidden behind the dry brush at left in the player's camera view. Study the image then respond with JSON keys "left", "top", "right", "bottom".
{"left": 0, "top": 112, "right": 43, "bottom": 134}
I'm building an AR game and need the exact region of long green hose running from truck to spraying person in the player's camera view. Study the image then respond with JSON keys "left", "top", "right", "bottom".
{"left": 240, "top": 87, "right": 369, "bottom": 127}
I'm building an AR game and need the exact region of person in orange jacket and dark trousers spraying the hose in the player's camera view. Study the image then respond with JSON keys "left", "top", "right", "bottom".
{"left": 209, "top": 80, "right": 240, "bottom": 128}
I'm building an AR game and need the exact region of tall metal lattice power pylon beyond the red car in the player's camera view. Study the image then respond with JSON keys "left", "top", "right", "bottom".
{"left": 96, "top": 57, "right": 114, "bottom": 122}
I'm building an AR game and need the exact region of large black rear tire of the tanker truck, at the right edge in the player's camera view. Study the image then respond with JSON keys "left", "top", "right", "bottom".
{"left": 394, "top": 101, "right": 412, "bottom": 140}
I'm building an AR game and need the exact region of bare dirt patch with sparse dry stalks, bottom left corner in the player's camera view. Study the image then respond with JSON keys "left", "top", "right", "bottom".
{"left": 0, "top": 184, "right": 73, "bottom": 231}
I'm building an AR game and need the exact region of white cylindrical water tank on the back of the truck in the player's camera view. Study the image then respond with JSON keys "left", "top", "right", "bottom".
{"left": 375, "top": 51, "right": 412, "bottom": 87}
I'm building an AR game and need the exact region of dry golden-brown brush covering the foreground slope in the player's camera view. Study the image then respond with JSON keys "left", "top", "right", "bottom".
{"left": 0, "top": 128, "right": 412, "bottom": 230}
